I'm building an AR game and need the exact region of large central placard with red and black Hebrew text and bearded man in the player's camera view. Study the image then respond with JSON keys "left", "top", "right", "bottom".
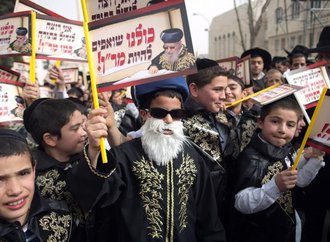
{"left": 89, "top": 1, "right": 196, "bottom": 90}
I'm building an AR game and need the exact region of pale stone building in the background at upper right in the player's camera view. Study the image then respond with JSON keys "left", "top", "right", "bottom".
{"left": 208, "top": 0, "right": 330, "bottom": 60}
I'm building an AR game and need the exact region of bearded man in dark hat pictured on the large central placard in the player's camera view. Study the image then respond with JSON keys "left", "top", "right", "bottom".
{"left": 148, "top": 28, "right": 195, "bottom": 74}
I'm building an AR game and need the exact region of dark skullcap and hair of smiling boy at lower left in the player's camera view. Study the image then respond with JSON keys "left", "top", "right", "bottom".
{"left": 0, "top": 128, "right": 35, "bottom": 167}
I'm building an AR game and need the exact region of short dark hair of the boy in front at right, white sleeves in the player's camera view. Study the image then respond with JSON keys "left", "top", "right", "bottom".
{"left": 260, "top": 96, "right": 301, "bottom": 121}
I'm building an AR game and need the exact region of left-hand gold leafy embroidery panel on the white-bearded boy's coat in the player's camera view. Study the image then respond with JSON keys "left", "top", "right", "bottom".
{"left": 132, "top": 158, "right": 164, "bottom": 238}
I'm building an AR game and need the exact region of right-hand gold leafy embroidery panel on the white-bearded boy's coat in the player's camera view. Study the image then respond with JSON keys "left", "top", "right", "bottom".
{"left": 175, "top": 155, "right": 197, "bottom": 232}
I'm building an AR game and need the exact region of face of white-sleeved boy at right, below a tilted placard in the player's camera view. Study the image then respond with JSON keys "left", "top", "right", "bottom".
{"left": 259, "top": 108, "right": 298, "bottom": 147}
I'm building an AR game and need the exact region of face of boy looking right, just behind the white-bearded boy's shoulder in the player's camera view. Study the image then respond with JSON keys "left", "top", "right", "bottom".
{"left": 190, "top": 76, "right": 228, "bottom": 113}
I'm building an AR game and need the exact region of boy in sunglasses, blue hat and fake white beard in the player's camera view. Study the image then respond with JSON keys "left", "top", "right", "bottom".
{"left": 87, "top": 78, "right": 225, "bottom": 242}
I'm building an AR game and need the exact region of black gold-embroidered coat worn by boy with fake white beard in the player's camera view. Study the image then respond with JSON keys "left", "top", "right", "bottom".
{"left": 94, "top": 139, "right": 224, "bottom": 242}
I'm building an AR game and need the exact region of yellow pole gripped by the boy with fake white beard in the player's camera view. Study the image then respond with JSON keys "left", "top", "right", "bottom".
{"left": 81, "top": 0, "right": 108, "bottom": 163}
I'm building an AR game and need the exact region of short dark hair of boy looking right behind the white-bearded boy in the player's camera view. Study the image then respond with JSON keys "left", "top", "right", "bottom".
{"left": 187, "top": 65, "right": 229, "bottom": 88}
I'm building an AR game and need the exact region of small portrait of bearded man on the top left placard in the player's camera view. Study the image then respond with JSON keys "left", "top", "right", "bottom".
{"left": 7, "top": 27, "right": 31, "bottom": 54}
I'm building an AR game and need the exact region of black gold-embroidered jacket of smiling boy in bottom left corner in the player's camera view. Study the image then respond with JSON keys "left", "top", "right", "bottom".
{"left": 0, "top": 189, "right": 75, "bottom": 242}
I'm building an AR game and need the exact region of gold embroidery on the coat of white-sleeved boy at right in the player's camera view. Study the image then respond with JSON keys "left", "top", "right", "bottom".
{"left": 261, "top": 161, "right": 294, "bottom": 219}
